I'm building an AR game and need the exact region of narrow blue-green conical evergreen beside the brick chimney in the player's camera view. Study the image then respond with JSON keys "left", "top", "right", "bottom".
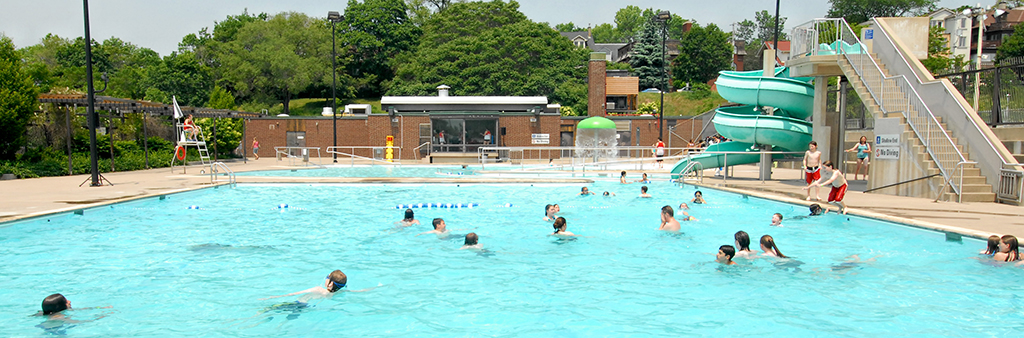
{"left": 630, "top": 19, "right": 668, "bottom": 90}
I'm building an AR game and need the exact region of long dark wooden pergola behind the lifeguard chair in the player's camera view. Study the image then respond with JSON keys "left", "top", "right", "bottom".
{"left": 39, "top": 93, "right": 264, "bottom": 174}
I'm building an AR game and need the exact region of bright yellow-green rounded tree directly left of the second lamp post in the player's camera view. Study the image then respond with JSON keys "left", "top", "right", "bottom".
{"left": 216, "top": 12, "right": 331, "bottom": 114}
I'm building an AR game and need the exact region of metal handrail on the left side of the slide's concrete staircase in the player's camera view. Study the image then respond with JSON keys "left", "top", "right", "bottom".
{"left": 794, "top": 18, "right": 967, "bottom": 195}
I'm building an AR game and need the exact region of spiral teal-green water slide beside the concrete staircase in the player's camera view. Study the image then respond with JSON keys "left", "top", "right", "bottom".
{"left": 672, "top": 67, "right": 814, "bottom": 174}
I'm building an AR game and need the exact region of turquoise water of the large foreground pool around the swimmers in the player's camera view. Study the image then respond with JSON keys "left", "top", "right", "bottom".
{"left": 0, "top": 182, "right": 1024, "bottom": 337}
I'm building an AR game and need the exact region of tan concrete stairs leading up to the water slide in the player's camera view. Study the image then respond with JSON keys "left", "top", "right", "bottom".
{"left": 839, "top": 54, "right": 995, "bottom": 202}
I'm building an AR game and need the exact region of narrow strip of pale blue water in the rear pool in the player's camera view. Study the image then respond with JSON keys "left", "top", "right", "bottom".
{"left": 238, "top": 166, "right": 473, "bottom": 177}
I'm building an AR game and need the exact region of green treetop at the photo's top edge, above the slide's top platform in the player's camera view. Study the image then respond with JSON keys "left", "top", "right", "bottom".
{"left": 827, "top": 0, "right": 938, "bottom": 24}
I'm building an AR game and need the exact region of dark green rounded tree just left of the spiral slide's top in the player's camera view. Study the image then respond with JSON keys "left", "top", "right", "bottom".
{"left": 672, "top": 24, "right": 732, "bottom": 83}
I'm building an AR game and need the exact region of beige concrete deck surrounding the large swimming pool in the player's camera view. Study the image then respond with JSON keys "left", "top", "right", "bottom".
{"left": 0, "top": 158, "right": 1024, "bottom": 238}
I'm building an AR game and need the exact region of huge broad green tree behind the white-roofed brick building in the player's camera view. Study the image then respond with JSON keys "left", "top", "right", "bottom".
{"left": 387, "top": 1, "right": 588, "bottom": 112}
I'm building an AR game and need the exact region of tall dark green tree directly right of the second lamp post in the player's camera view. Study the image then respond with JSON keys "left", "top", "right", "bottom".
{"left": 342, "top": 0, "right": 422, "bottom": 97}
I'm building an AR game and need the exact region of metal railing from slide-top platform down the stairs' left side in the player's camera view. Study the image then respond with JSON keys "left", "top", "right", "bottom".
{"left": 793, "top": 18, "right": 967, "bottom": 195}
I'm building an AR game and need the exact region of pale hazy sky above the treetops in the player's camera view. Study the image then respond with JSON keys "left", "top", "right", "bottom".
{"left": 0, "top": 0, "right": 977, "bottom": 55}
